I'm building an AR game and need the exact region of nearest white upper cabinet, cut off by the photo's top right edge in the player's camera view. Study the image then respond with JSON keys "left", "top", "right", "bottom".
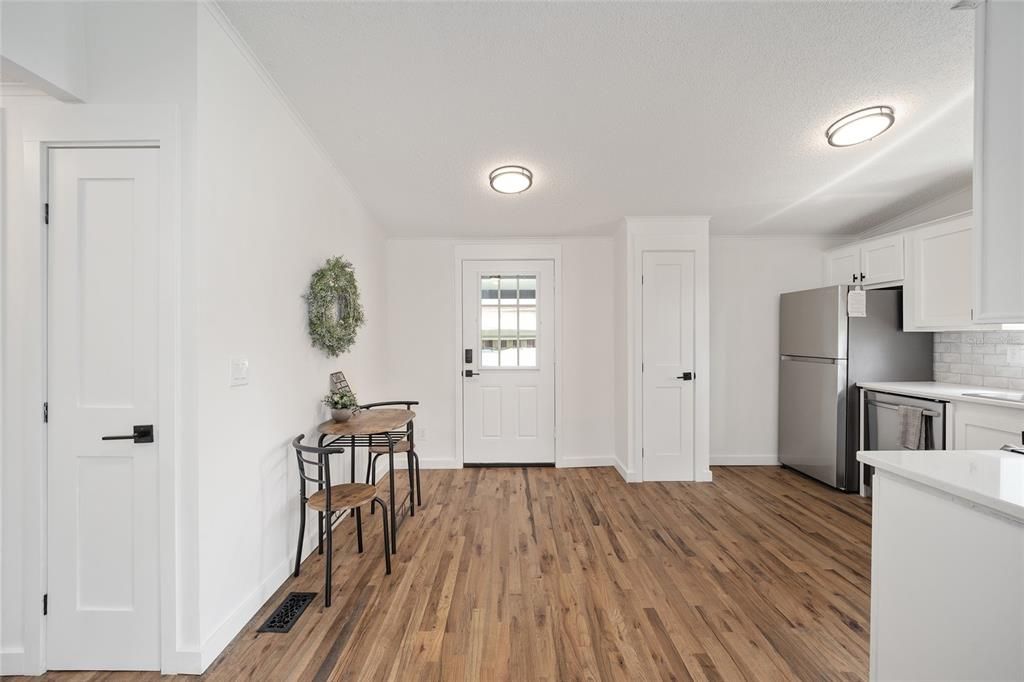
{"left": 974, "top": 0, "right": 1024, "bottom": 323}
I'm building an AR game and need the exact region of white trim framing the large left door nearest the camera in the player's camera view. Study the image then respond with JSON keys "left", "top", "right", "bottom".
{"left": 4, "top": 104, "right": 181, "bottom": 674}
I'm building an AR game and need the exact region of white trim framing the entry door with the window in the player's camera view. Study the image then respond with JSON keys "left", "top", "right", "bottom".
{"left": 452, "top": 241, "right": 562, "bottom": 468}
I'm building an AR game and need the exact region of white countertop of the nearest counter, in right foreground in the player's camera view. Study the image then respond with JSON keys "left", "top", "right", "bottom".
{"left": 857, "top": 450, "right": 1024, "bottom": 522}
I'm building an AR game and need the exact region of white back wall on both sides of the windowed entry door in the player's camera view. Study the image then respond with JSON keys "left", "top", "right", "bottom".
{"left": 385, "top": 237, "right": 616, "bottom": 467}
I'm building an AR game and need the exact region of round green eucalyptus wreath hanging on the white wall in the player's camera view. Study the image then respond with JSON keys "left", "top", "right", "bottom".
{"left": 303, "top": 258, "right": 365, "bottom": 357}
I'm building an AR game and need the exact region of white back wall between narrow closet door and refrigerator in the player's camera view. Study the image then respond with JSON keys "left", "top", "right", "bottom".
{"left": 711, "top": 237, "right": 842, "bottom": 465}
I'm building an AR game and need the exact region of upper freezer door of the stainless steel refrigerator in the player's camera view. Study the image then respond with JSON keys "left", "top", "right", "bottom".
{"left": 778, "top": 286, "right": 849, "bottom": 358}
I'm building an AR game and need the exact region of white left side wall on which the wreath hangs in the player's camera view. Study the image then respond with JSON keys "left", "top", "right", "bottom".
{"left": 192, "top": 6, "right": 387, "bottom": 665}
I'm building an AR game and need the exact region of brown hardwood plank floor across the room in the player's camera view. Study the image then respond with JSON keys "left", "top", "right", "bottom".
{"left": 24, "top": 467, "right": 870, "bottom": 681}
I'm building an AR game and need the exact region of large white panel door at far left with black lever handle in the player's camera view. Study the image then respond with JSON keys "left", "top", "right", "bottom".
{"left": 46, "top": 148, "right": 160, "bottom": 670}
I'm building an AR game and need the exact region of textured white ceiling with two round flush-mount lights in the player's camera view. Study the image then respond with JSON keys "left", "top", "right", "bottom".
{"left": 221, "top": 0, "right": 974, "bottom": 237}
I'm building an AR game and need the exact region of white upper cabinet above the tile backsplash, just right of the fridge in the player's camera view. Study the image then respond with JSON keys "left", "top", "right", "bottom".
{"left": 903, "top": 215, "right": 973, "bottom": 330}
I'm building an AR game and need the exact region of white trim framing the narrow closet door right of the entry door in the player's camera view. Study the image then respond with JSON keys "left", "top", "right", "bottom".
{"left": 623, "top": 216, "right": 712, "bottom": 481}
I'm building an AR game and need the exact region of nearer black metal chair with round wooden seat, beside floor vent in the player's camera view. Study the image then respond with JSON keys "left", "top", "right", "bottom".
{"left": 292, "top": 435, "right": 391, "bottom": 606}
